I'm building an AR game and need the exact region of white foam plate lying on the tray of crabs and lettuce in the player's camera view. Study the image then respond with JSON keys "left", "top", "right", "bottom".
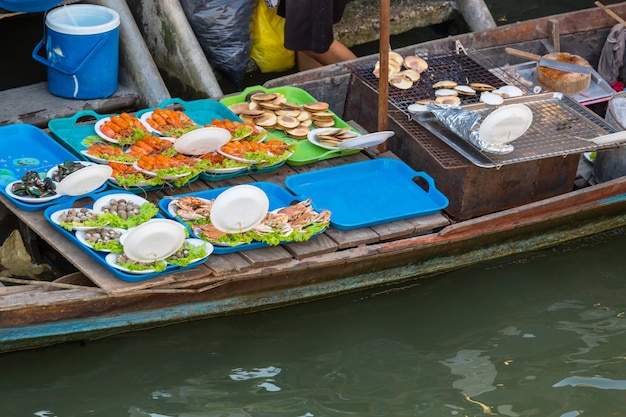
{"left": 210, "top": 184, "right": 269, "bottom": 233}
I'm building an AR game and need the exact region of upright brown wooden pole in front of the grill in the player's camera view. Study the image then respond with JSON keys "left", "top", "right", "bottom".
{"left": 378, "top": 0, "right": 390, "bottom": 152}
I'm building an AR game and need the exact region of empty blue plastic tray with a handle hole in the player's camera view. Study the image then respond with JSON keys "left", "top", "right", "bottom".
{"left": 285, "top": 158, "right": 448, "bottom": 230}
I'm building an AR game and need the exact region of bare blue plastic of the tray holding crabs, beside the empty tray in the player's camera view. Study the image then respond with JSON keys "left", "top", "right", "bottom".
{"left": 159, "top": 181, "right": 300, "bottom": 255}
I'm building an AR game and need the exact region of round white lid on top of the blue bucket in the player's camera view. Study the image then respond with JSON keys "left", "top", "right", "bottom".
{"left": 46, "top": 4, "right": 120, "bottom": 35}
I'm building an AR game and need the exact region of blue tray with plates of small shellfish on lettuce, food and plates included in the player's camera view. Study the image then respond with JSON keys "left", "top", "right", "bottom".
{"left": 44, "top": 191, "right": 213, "bottom": 282}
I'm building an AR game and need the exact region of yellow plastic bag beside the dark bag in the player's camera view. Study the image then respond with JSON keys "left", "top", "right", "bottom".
{"left": 250, "top": 0, "right": 296, "bottom": 72}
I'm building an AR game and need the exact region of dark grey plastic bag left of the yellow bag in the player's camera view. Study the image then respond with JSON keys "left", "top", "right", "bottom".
{"left": 180, "top": 0, "right": 256, "bottom": 88}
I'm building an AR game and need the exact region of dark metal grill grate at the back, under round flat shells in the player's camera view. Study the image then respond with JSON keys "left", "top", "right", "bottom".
{"left": 349, "top": 52, "right": 528, "bottom": 114}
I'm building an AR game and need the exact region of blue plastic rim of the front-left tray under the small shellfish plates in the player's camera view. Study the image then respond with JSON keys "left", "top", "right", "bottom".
{"left": 44, "top": 190, "right": 205, "bottom": 282}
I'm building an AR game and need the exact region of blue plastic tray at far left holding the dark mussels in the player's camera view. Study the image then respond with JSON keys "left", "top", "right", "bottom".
{"left": 0, "top": 124, "right": 105, "bottom": 211}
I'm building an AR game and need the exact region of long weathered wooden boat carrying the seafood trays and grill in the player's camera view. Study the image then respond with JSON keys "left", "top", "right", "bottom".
{"left": 0, "top": 3, "right": 626, "bottom": 351}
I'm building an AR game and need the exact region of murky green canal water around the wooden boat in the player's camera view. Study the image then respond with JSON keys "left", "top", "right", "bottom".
{"left": 0, "top": 0, "right": 626, "bottom": 417}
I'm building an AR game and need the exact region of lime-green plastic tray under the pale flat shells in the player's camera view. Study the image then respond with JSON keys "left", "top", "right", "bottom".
{"left": 220, "top": 85, "right": 360, "bottom": 166}
